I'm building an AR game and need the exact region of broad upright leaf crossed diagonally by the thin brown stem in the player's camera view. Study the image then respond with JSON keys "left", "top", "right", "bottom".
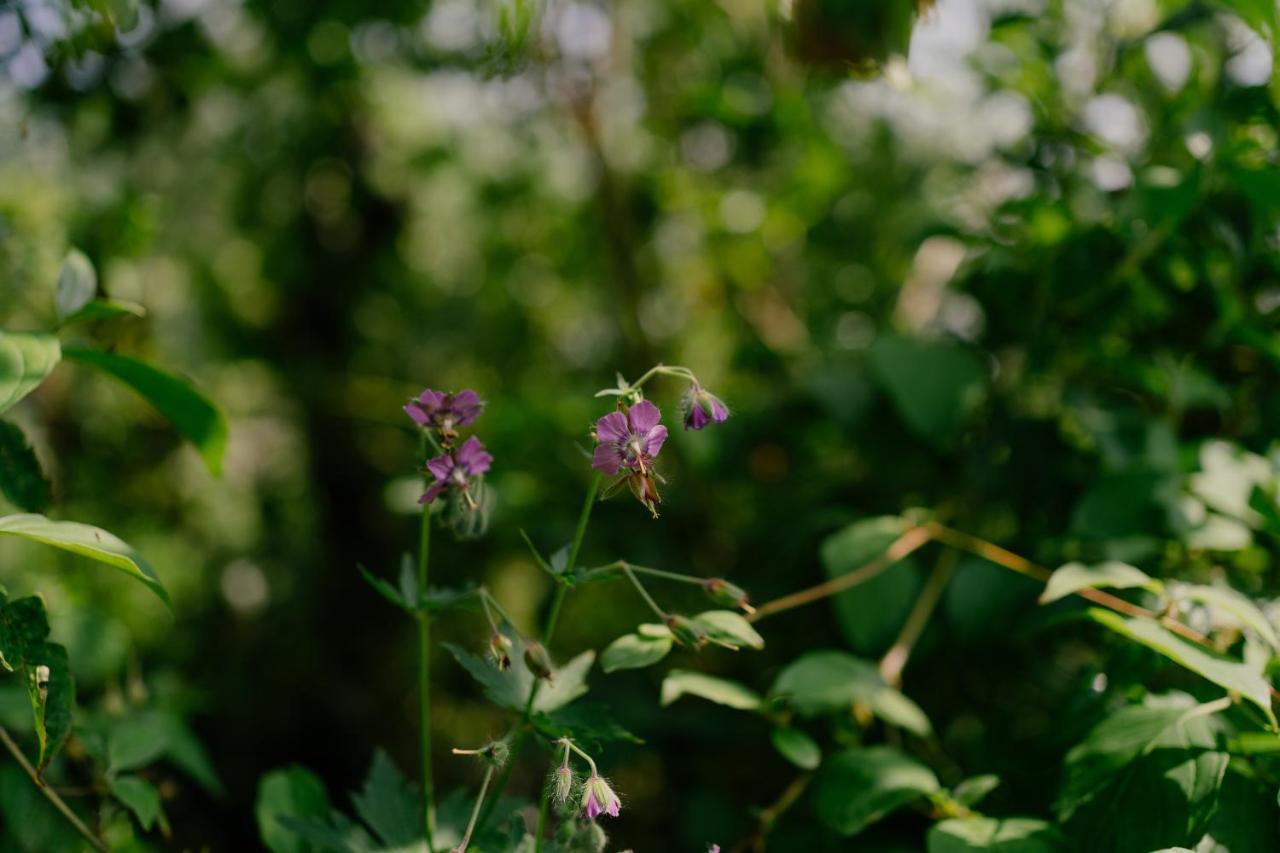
{"left": 822, "top": 516, "right": 924, "bottom": 656}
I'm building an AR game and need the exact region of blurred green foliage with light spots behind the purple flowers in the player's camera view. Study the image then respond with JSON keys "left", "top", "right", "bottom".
{"left": 0, "top": 0, "right": 1280, "bottom": 850}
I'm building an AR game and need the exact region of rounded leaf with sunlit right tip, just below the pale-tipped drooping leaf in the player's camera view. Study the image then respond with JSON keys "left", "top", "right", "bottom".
{"left": 813, "top": 747, "right": 940, "bottom": 835}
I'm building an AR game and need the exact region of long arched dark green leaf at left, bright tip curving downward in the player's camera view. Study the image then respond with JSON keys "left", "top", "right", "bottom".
{"left": 64, "top": 346, "right": 227, "bottom": 475}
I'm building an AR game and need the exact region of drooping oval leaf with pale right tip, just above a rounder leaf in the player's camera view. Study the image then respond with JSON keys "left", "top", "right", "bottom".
{"left": 769, "top": 651, "right": 932, "bottom": 738}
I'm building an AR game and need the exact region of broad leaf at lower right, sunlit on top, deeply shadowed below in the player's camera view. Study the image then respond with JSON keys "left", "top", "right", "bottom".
{"left": 1057, "top": 698, "right": 1229, "bottom": 853}
